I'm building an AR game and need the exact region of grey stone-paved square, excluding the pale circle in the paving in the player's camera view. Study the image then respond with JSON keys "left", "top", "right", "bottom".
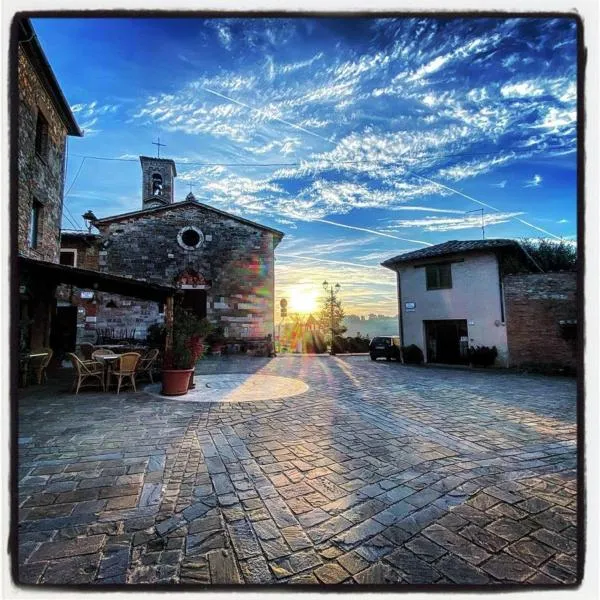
{"left": 18, "top": 356, "right": 578, "bottom": 585}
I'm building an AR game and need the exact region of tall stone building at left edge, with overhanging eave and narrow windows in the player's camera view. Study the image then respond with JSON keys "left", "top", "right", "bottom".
{"left": 13, "top": 19, "right": 82, "bottom": 348}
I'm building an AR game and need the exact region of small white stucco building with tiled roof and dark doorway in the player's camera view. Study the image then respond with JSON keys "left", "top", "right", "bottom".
{"left": 381, "top": 239, "right": 521, "bottom": 366}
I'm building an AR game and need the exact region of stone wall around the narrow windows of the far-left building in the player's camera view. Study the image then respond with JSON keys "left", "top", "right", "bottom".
{"left": 17, "top": 47, "right": 67, "bottom": 262}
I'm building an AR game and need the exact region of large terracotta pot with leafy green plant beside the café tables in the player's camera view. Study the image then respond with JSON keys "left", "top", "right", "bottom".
{"left": 161, "top": 306, "right": 211, "bottom": 396}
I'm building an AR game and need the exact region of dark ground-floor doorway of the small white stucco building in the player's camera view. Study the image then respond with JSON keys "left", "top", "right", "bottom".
{"left": 424, "top": 319, "right": 469, "bottom": 365}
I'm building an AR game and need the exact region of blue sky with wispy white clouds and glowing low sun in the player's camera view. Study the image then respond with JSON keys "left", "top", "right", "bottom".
{"left": 33, "top": 17, "right": 577, "bottom": 315}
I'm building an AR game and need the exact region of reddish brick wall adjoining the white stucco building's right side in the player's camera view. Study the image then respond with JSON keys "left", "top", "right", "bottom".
{"left": 504, "top": 273, "right": 577, "bottom": 368}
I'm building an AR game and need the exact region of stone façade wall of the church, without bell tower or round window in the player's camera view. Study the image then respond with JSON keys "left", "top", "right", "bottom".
{"left": 58, "top": 203, "right": 274, "bottom": 343}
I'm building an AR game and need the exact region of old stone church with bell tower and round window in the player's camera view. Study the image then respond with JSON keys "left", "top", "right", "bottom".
{"left": 58, "top": 156, "right": 283, "bottom": 343}
